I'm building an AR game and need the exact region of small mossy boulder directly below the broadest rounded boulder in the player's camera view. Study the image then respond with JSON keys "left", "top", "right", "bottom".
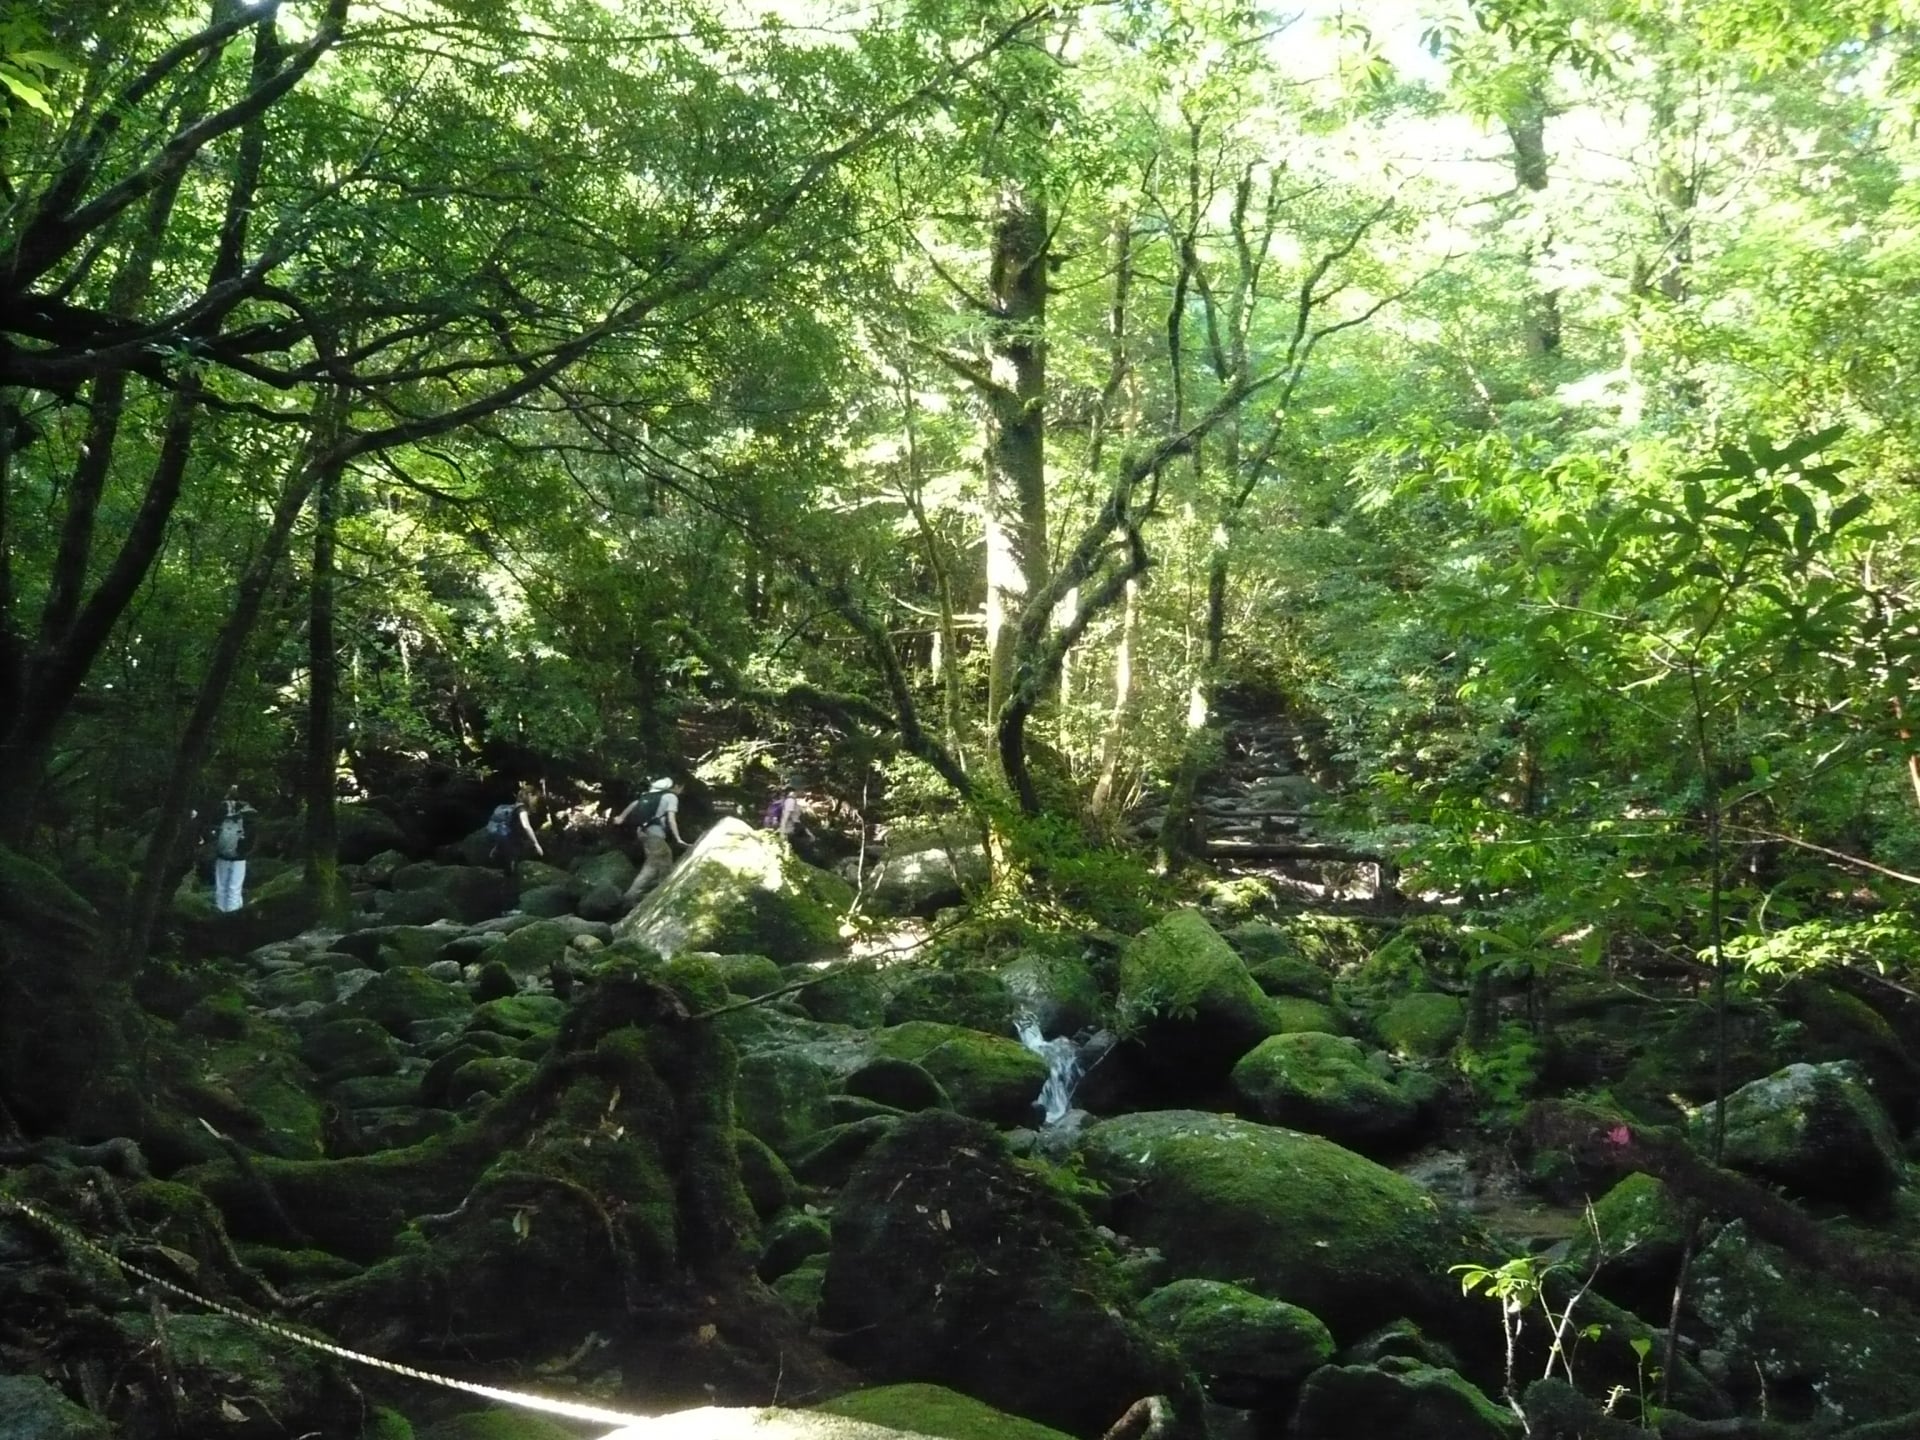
{"left": 1140, "top": 1281, "right": 1332, "bottom": 1405}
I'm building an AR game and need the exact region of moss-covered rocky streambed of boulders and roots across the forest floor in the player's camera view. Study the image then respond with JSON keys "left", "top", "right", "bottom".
{"left": 0, "top": 822, "right": 1920, "bottom": 1440}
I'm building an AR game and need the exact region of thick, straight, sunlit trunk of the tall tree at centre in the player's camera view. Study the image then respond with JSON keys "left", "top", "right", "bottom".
{"left": 983, "top": 184, "right": 1050, "bottom": 733}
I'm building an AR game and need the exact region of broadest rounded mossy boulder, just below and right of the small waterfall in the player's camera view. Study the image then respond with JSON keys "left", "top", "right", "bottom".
{"left": 1079, "top": 1110, "right": 1494, "bottom": 1342}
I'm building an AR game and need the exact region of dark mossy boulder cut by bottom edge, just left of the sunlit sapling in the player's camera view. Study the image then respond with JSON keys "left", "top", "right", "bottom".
{"left": 1290, "top": 1359, "right": 1524, "bottom": 1440}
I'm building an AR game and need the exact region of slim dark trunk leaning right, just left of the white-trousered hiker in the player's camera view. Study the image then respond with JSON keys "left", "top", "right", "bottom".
{"left": 119, "top": 445, "right": 332, "bottom": 973}
